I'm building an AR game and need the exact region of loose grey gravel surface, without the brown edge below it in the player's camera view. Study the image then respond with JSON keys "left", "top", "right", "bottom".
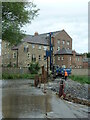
{"left": 47, "top": 78, "right": 90, "bottom": 100}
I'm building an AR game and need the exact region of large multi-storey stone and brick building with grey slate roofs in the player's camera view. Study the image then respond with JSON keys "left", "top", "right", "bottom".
{"left": 2, "top": 30, "right": 82, "bottom": 68}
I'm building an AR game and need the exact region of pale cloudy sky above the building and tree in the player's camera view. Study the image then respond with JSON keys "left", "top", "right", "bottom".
{"left": 23, "top": 0, "right": 89, "bottom": 53}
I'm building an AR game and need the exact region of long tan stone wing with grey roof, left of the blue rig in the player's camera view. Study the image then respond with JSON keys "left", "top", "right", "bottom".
{"left": 2, "top": 35, "right": 49, "bottom": 67}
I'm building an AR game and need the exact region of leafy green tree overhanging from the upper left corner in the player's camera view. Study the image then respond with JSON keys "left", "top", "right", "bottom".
{"left": 2, "top": 2, "right": 39, "bottom": 44}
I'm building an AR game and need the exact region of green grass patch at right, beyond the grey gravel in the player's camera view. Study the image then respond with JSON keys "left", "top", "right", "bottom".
{"left": 69, "top": 75, "right": 90, "bottom": 84}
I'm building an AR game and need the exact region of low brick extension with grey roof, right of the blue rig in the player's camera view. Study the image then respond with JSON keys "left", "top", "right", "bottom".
{"left": 55, "top": 48, "right": 82, "bottom": 68}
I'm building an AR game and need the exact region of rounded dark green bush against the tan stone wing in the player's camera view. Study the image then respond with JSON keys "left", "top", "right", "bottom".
{"left": 29, "top": 62, "right": 40, "bottom": 74}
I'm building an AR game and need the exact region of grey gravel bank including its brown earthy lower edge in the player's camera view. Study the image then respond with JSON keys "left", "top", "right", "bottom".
{"left": 41, "top": 78, "right": 90, "bottom": 106}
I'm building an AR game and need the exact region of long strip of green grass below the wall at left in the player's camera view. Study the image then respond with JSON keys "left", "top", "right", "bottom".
{"left": 2, "top": 74, "right": 36, "bottom": 80}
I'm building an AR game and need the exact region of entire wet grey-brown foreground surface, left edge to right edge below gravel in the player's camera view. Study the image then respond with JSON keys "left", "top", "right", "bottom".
{"left": 0, "top": 80, "right": 88, "bottom": 119}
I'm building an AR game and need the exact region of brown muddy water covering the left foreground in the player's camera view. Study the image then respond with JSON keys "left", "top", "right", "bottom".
{"left": 2, "top": 80, "right": 51, "bottom": 118}
